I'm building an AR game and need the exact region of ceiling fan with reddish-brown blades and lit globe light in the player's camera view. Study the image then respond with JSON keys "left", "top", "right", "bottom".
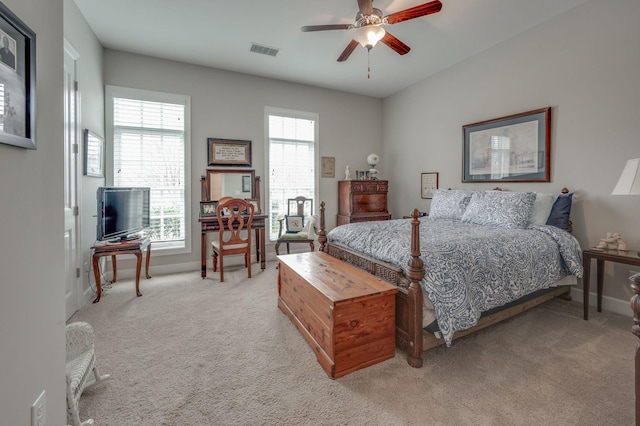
{"left": 300, "top": 0, "right": 442, "bottom": 62}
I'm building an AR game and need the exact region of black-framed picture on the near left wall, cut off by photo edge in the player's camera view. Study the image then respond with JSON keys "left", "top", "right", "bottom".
{"left": 0, "top": 3, "right": 37, "bottom": 149}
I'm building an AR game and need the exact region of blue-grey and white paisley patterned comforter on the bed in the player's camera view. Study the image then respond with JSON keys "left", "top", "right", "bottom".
{"left": 327, "top": 217, "right": 582, "bottom": 346}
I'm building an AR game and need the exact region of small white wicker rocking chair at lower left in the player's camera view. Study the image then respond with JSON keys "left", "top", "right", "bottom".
{"left": 66, "top": 322, "right": 111, "bottom": 426}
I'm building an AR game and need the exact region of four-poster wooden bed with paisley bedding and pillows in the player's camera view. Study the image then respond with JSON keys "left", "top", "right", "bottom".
{"left": 318, "top": 189, "right": 582, "bottom": 367}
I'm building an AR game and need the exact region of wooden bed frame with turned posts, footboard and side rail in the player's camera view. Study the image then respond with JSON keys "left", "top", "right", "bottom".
{"left": 318, "top": 195, "right": 572, "bottom": 368}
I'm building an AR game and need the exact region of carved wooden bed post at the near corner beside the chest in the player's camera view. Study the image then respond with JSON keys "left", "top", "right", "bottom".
{"left": 407, "top": 209, "right": 424, "bottom": 368}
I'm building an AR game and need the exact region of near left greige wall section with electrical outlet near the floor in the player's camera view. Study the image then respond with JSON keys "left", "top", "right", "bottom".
{"left": 0, "top": 0, "right": 66, "bottom": 425}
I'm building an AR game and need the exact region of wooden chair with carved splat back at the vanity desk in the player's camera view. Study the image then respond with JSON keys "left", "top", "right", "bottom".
{"left": 211, "top": 197, "right": 254, "bottom": 282}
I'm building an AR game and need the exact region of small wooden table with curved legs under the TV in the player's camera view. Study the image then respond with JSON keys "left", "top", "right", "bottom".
{"left": 91, "top": 235, "right": 151, "bottom": 303}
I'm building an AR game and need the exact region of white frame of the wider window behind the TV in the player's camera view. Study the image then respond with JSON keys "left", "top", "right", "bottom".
{"left": 105, "top": 85, "right": 193, "bottom": 255}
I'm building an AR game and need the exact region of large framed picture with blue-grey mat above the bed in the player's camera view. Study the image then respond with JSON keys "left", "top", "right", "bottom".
{"left": 462, "top": 107, "right": 551, "bottom": 182}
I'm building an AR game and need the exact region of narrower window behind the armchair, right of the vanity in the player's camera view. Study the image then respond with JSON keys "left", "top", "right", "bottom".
{"left": 266, "top": 108, "right": 318, "bottom": 241}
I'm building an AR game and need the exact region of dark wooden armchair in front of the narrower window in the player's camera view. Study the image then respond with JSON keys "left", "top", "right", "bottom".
{"left": 276, "top": 197, "right": 315, "bottom": 255}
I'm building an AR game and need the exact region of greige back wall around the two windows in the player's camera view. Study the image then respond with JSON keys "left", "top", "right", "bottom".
{"left": 99, "top": 50, "right": 382, "bottom": 272}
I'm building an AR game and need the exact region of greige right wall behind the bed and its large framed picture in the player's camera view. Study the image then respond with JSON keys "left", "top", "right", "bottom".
{"left": 381, "top": 0, "right": 640, "bottom": 315}
